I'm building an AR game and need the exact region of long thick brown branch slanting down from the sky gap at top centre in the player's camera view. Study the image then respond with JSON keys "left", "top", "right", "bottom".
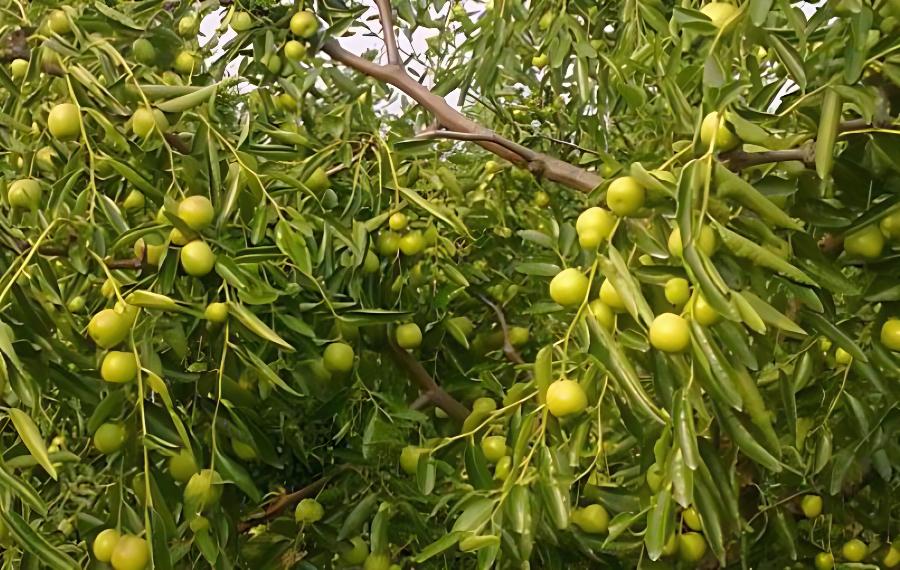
{"left": 322, "top": 39, "right": 603, "bottom": 192}
